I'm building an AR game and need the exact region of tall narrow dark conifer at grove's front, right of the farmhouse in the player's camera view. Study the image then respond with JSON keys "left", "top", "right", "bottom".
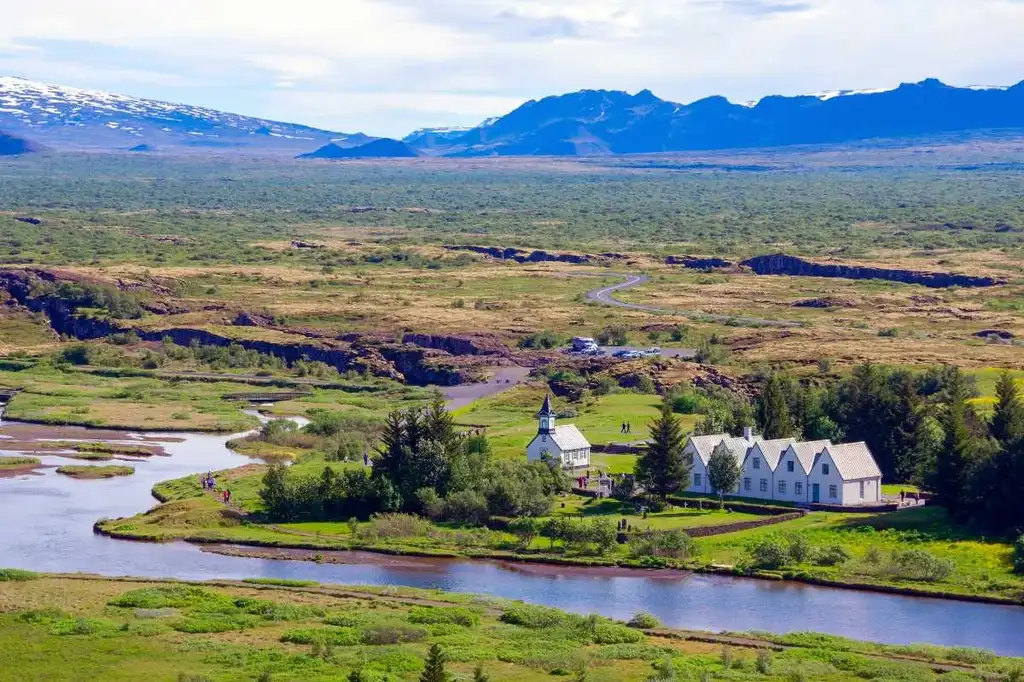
{"left": 932, "top": 372, "right": 976, "bottom": 516}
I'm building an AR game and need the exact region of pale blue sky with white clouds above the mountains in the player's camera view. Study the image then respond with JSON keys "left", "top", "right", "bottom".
{"left": 0, "top": 0, "right": 1024, "bottom": 136}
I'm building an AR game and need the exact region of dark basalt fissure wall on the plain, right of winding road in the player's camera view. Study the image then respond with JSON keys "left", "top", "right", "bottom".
{"left": 741, "top": 253, "right": 1005, "bottom": 289}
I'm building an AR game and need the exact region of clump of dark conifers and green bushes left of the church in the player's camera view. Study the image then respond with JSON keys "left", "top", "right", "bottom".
{"left": 260, "top": 398, "right": 568, "bottom": 525}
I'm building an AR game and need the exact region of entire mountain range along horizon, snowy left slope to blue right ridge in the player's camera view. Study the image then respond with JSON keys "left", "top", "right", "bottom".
{"left": 0, "top": 77, "right": 1024, "bottom": 159}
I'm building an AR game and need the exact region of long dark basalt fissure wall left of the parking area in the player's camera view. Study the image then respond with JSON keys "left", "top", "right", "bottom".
{"left": 0, "top": 270, "right": 495, "bottom": 386}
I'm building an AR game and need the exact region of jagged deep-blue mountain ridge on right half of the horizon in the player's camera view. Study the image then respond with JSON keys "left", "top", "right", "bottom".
{"left": 421, "top": 79, "right": 1024, "bottom": 157}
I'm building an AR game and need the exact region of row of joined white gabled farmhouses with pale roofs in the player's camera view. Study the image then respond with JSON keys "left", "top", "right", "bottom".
{"left": 683, "top": 428, "right": 882, "bottom": 507}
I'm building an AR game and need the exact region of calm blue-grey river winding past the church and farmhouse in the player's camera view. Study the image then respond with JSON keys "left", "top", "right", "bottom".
{"left": 0, "top": 413, "right": 1024, "bottom": 656}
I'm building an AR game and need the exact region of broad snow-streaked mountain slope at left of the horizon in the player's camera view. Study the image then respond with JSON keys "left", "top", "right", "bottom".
{"left": 0, "top": 76, "right": 372, "bottom": 151}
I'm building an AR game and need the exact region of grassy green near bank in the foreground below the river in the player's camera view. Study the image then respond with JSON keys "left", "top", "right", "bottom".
{"left": 0, "top": 570, "right": 1024, "bottom": 682}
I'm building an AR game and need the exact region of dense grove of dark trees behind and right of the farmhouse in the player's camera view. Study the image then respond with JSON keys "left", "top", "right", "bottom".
{"left": 756, "top": 365, "right": 1024, "bottom": 531}
